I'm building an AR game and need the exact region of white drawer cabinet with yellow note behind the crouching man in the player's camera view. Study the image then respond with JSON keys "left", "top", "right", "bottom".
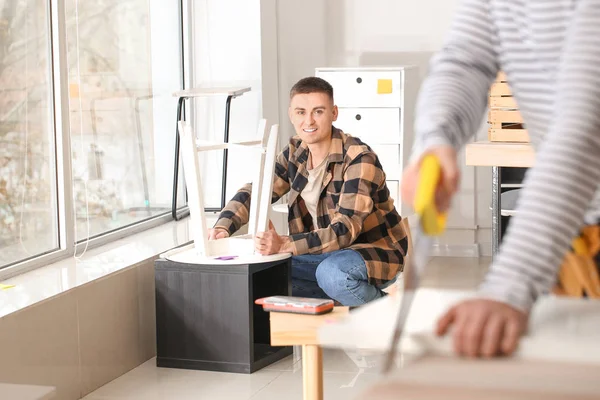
{"left": 315, "top": 66, "right": 419, "bottom": 216}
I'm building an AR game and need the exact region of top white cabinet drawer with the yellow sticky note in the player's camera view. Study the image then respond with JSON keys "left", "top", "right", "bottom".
{"left": 316, "top": 71, "right": 402, "bottom": 107}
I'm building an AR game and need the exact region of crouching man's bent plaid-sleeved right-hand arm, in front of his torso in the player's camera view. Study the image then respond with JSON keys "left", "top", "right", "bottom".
{"left": 280, "top": 153, "right": 385, "bottom": 255}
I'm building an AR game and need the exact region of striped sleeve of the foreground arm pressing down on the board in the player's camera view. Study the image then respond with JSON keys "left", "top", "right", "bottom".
{"left": 481, "top": 0, "right": 600, "bottom": 311}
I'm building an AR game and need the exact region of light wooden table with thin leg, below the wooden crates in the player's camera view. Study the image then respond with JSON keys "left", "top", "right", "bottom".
{"left": 465, "top": 141, "right": 535, "bottom": 255}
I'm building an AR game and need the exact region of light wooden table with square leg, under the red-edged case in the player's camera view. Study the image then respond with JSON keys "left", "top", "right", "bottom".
{"left": 270, "top": 307, "right": 348, "bottom": 400}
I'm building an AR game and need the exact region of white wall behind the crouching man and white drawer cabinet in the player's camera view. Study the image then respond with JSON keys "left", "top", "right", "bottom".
{"left": 277, "top": 0, "right": 491, "bottom": 254}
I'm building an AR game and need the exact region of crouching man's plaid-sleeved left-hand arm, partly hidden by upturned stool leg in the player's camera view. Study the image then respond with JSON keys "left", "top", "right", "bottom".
{"left": 214, "top": 145, "right": 290, "bottom": 236}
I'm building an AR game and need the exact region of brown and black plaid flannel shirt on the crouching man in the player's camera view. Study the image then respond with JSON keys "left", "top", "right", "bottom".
{"left": 215, "top": 127, "right": 408, "bottom": 284}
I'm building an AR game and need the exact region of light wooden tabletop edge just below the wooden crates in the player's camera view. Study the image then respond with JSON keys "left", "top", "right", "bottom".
{"left": 465, "top": 142, "right": 535, "bottom": 168}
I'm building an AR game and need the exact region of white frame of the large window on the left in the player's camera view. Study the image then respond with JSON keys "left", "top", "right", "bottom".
{"left": 0, "top": 0, "right": 193, "bottom": 280}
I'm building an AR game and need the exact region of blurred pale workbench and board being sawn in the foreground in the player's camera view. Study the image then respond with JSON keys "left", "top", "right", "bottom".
{"left": 318, "top": 288, "right": 600, "bottom": 400}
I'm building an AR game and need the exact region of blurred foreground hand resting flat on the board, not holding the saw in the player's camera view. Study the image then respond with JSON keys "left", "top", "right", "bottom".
{"left": 437, "top": 299, "right": 528, "bottom": 357}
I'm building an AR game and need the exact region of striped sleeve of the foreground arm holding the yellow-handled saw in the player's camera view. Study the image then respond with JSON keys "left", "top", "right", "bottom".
{"left": 412, "top": 0, "right": 499, "bottom": 160}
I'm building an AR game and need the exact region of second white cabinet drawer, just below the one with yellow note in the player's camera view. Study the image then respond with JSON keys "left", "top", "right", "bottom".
{"left": 333, "top": 108, "right": 401, "bottom": 145}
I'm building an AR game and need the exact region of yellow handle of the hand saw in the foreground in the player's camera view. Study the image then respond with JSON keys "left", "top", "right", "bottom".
{"left": 414, "top": 154, "right": 447, "bottom": 236}
